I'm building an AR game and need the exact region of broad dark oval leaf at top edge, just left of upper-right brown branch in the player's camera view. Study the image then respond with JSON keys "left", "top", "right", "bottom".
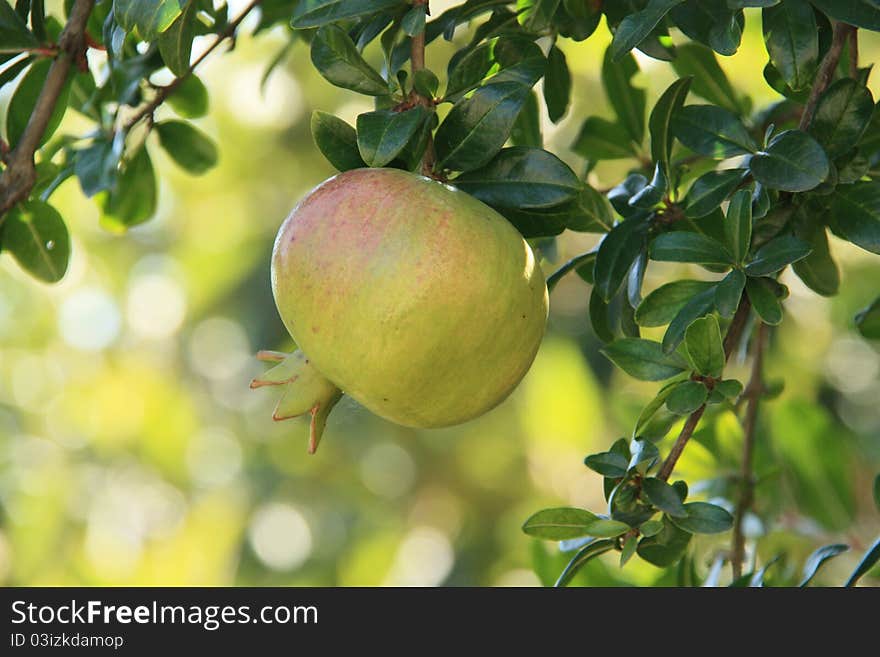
{"left": 762, "top": 0, "right": 819, "bottom": 90}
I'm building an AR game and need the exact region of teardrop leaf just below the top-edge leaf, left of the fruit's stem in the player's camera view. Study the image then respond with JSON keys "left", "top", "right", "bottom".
{"left": 311, "top": 25, "right": 389, "bottom": 96}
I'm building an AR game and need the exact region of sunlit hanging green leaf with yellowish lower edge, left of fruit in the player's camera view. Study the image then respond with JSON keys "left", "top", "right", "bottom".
{"left": 101, "top": 146, "right": 156, "bottom": 231}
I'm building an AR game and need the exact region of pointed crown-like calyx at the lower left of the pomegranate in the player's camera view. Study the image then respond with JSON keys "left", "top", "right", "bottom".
{"left": 251, "top": 349, "right": 342, "bottom": 454}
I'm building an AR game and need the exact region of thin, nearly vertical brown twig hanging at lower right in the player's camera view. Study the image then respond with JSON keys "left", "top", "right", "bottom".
{"left": 730, "top": 322, "right": 767, "bottom": 579}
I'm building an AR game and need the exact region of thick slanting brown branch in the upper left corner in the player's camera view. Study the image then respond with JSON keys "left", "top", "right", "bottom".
{"left": 0, "top": 0, "right": 95, "bottom": 220}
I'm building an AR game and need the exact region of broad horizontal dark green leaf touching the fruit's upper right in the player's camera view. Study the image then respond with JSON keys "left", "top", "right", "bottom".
{"left": 453, "top": 146, "right": 583, "bottom": 208}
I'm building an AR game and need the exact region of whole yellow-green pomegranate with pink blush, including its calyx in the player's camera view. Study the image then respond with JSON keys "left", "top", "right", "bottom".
{"left": 251, "top": 168, "right": 548, "bottom": 452}
